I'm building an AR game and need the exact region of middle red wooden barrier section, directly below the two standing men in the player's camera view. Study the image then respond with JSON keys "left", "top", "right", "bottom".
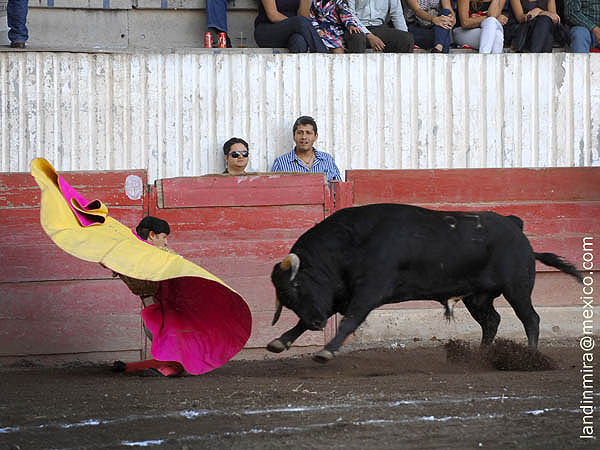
{"left": 150, "top": 174, "right": 334, "bottom": 348}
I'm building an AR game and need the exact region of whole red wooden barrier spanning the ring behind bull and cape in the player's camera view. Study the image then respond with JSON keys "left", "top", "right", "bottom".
{"left": 0, "top": 168, "right": 600, "bottom": 364}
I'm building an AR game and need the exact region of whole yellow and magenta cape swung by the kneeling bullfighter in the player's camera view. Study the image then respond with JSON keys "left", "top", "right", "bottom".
{"left": 31, "top": 158, "right": 252, "bottom": 375}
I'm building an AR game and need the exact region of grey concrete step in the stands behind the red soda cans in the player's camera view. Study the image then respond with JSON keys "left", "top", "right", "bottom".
{"left": 0, "top": 0, "right": 257, "bottom": 51}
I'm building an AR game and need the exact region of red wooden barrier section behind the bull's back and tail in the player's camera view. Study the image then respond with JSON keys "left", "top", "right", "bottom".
{"left": 345, "top": 167, "right": 600, "bottom": 308}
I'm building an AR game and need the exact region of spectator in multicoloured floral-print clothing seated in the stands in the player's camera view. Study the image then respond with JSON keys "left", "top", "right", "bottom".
{"left": 310, "top": 0, "right": 362, "bottom": 53}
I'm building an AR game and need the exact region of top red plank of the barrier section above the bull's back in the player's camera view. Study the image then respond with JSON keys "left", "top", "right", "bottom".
{"left": 346, "top": 167, "right": 600, "bottom": 205}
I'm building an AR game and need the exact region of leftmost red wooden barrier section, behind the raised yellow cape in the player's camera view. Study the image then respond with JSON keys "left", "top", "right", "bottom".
{"left": 0, "top": 170, "right": 147, "bottom": 359}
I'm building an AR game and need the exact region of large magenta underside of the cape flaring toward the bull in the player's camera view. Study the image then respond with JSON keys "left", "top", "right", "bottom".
{"left": 142, "top": 277, "right": 252, "bottom": 375}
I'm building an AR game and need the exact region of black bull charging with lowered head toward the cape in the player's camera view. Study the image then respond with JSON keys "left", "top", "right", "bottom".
{"left": 267, "top": 204, "right": 581, "bottom": 362}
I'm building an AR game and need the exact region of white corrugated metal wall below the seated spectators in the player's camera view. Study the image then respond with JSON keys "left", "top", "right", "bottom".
{"left": 0, "top": 52, "right": 600, "bottom": 181}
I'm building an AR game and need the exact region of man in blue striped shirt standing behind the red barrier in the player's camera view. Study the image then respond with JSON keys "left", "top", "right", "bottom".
{"left": 271, "top": 116, "right": 342, "bottom": 181}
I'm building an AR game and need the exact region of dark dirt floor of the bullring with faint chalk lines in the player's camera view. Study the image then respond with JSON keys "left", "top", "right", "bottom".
{"left": 0, "top": 342, "right": 599, "bottom": 450}
